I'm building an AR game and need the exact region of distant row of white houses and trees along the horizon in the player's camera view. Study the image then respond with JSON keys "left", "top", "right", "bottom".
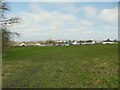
{"left": 13, "top": 39, "right": 118, "bottom": 46}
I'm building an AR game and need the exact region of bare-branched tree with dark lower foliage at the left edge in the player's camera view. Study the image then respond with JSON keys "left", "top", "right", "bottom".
{"left": 0, "top": 0, "right": 20, "bottom": 49}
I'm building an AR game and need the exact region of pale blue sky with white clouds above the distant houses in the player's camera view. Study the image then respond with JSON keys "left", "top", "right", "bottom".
{"left": 7, "top": 2, "right": 118, "bottom": 41}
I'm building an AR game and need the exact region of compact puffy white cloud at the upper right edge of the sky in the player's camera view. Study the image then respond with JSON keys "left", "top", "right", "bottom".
{"left": 99, "top": 8, "right": 118, "bottom": 23}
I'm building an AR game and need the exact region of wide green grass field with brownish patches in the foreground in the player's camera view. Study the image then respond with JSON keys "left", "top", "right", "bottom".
{"left": 2, "top": 45, "right": 118, "bottom": 88}
